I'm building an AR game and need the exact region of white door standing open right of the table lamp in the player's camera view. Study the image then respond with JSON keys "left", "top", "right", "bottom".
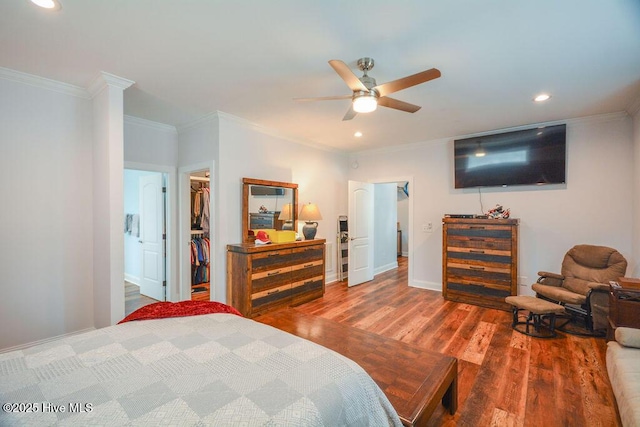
{"left": 348, "top": 181, "right": 373, "bottom": 286}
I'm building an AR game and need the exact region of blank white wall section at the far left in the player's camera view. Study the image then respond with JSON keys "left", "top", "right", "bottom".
{"left": 0, "top": 73, "right": 94, "bottom": 349}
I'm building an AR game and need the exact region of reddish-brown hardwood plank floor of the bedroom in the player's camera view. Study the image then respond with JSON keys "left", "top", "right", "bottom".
{"left": 294, "top": 258, "right": 621, "bottom": 427}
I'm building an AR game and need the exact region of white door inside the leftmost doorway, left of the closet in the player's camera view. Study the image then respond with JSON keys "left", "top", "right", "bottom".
{"left": 138, "top": 173, "right": 165, "bottom": 301}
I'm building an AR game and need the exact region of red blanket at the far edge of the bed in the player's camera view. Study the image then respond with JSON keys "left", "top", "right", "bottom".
{"left": 118, "top": 301, "right": 242, "bottom": 324}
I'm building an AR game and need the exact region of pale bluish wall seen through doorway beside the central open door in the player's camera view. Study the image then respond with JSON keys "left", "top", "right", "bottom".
{"left": 373, "top": 182, "right": 398, "bottom": 274}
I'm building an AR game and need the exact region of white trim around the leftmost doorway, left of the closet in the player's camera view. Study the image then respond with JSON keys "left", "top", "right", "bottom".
{"left": 123, "top": 161, "right": 179, "bottom": 300}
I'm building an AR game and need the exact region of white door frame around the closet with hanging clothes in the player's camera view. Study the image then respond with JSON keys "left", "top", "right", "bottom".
{"left": 178, "top": 162, "right": 218, "bottom": 301}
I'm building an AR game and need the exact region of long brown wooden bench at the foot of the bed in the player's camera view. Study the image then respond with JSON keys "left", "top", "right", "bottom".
{"left": 254, "top": 310, "right": 458, "bottom": 426}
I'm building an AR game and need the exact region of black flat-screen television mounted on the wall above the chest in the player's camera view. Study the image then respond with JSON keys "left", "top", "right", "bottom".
{"left": 453, "top": 125, "right": 567, "bottom": 188}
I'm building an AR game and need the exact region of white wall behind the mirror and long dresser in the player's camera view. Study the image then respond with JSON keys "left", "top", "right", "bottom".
{"left": 212, "top": 114, "right": 348, "bottom": 301}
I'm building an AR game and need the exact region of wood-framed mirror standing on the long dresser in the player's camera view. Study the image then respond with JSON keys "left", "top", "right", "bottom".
{"left": 242, "top": 178, "right": 298, "bottom": 243}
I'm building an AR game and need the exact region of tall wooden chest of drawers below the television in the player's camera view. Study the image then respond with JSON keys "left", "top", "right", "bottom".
{"left": 442, "top": 218, "right": 518, "bottom": 310}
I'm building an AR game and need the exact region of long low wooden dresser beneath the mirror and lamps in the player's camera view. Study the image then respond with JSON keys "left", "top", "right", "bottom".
{"left": 227, "top": 239, "right": 325, "bottom": 317}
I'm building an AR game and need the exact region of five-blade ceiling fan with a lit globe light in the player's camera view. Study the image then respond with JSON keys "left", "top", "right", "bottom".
{"left": 294, "top": 58, "right": 441, "bottom": 120}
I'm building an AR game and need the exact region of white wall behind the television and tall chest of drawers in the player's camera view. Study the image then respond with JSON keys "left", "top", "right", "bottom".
{"left": 349, "top": 114, "right": 634, "bottom": 293}
